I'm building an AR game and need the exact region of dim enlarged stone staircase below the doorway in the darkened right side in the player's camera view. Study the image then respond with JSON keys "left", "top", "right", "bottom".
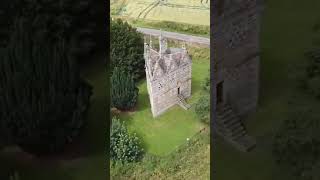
{"left": 216, "top": 104, "right": 256, "bottom": 152}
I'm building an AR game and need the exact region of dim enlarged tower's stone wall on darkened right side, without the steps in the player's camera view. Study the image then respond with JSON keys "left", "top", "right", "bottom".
{"left": 212, "top": 1, "right": 260, "bottom": 115}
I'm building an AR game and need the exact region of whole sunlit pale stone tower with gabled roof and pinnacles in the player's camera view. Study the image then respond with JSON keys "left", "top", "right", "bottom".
{"left": 144, "top": 34, "right": 192, "bottom": 117}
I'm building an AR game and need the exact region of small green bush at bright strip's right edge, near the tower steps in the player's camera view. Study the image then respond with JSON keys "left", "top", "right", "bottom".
{"left": 195, "top": 94, "right": 210, "bottom": 124}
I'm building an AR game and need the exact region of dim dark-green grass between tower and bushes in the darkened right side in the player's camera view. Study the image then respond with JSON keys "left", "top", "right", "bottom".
{"left": 213, "top": 0, "right": 320, "bottom": 180}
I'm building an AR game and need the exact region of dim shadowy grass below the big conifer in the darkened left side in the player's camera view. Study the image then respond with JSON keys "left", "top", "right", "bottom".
{"left": 0, "top": 57, "right": 108, "bottom": 180}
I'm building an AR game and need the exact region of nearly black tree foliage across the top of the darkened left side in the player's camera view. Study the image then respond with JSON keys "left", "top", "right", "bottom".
{"left": 0, "top": 0, "right": 103, "bottom": 58}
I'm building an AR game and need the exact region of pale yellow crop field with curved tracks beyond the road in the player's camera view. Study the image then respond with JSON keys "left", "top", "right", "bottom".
{"left": 110, "top": 0, "right": 210, "bottom": 25}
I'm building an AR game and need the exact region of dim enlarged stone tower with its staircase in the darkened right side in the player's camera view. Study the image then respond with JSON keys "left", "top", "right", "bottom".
{"left": 211, "top": 0, "right": 262, "bottom": 151}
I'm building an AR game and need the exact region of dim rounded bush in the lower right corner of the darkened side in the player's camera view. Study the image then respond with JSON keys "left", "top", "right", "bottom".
{"left": 273, "top": 112, "right": 320, "bottom": 180}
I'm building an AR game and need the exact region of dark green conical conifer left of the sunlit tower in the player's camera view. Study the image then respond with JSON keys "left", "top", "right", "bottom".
{"left": 111, "top": 67, "right": 139, "bottom": 110}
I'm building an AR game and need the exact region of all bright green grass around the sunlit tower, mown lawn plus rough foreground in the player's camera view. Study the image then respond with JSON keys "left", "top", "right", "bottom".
{"left": 111, "top": 42, "right": 210, "bottom": 180}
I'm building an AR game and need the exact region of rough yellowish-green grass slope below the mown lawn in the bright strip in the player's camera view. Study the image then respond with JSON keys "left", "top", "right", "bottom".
{"left": 111, "top": 127, "right": 210, "bottom": 180}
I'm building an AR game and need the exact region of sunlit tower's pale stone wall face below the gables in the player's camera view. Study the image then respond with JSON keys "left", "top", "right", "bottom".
{"left": 148, "top": 64, "right": 191, "bottom": 116}
